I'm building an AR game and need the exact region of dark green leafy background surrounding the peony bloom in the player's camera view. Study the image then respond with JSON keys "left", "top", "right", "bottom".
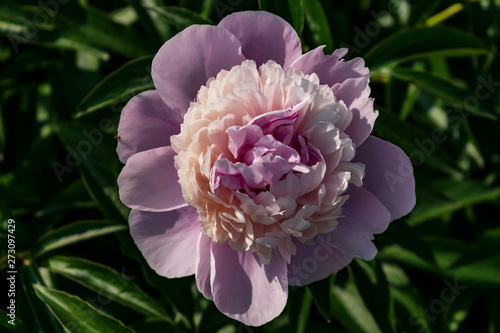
{"left": 0, "top": 0, "right": 500, "bottom": 333}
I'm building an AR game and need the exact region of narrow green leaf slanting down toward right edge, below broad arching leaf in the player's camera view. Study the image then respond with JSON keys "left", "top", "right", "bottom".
{"left": 389, "top": 68, "right": 496, "bottom": 120}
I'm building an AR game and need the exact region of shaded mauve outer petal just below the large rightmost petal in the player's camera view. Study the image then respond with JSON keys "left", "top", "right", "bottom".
{"left": 328, "top": 187, "right": 391, "bottom": 260}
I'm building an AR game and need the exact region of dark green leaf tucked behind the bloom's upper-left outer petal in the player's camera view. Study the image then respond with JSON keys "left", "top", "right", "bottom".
{"left": 75, "top": 56, "right": 154, "bottom": 118}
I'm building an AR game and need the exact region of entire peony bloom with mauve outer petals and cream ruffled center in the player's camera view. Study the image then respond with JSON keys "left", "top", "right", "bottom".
{"left": 117, "top": 12, "right": 415, "bottom": 326}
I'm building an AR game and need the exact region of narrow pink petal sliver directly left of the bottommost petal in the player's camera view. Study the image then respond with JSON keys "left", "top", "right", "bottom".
{"left": 196, "top": 232, "right": 213, "bottom": 300}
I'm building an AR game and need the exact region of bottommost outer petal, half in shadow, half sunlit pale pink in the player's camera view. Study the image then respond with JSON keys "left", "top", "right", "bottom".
{"left": 210, "top": 243, "right": 288, "bottom": 326}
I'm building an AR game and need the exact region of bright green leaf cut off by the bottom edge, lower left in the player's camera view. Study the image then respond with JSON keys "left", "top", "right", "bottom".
{"left": 33, "top": 285, "right": 133, "bottom": 333}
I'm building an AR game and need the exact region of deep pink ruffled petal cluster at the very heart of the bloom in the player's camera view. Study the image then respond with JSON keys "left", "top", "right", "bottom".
{"left": 210, "top": 103, "right": 324, "bottom": 198}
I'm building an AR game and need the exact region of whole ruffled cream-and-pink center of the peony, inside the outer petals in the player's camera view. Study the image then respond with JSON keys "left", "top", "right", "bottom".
{"left": 171, "top": 61, "right": 364, "bottom": 263}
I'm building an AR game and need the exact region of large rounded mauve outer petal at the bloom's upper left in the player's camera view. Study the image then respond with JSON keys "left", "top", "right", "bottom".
{"left": 152, "top": 25, "right": 245, "bottom": 113}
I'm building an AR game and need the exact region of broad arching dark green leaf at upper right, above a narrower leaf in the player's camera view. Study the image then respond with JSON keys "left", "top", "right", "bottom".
{"left": 363, "top": 26, "right": 490, "bottom": 71}
